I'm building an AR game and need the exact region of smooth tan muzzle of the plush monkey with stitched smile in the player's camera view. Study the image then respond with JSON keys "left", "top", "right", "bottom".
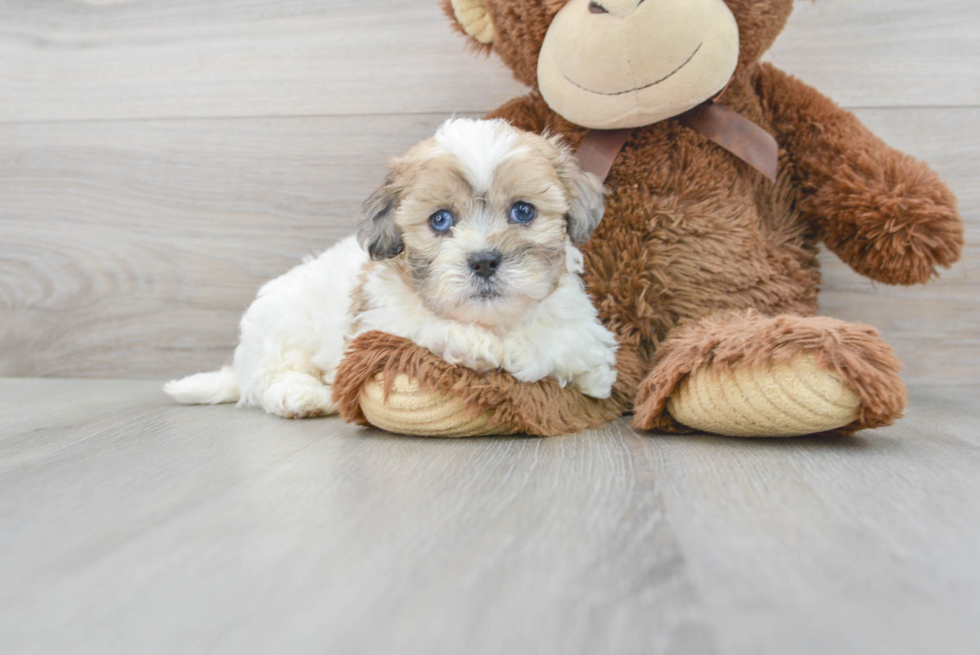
{"left": 538, "top": 0, "right": 738, "bottom": 129}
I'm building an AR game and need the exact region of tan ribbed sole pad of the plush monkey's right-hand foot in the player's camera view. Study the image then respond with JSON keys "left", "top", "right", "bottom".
{"left": 667, "top": 355, "right": 861, "bottom": 437}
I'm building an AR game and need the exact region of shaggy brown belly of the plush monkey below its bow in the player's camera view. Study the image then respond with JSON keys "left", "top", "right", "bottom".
{"left": 583, "top": 121, "right": 820, "bottom": 362}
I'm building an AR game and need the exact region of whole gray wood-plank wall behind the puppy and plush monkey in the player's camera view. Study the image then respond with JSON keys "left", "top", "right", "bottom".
{"left": 0, "top": 0, "right": 980, "bottom": 384}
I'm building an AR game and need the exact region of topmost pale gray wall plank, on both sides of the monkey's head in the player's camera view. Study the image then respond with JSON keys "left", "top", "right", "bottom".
{"left": 0, "top": 0, "right": 980, "bottom": 121}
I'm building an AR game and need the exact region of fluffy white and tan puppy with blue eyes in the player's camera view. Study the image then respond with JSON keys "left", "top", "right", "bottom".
{"left": 164, "top": 119, "right": 617, "bottom": 418}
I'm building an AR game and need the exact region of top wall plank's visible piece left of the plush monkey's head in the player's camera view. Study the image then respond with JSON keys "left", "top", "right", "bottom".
{"left": 0, "top": 0, "right": 524, "bottom": 121}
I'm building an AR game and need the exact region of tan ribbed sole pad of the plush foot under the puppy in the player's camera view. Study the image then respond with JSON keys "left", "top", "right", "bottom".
{"left": 359, "top": 374, "right": 514, "bottom": 437}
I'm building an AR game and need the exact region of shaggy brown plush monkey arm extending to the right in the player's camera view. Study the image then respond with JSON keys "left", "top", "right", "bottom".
{"left": 757, "top": 64, "right": 963, "bottom": 285}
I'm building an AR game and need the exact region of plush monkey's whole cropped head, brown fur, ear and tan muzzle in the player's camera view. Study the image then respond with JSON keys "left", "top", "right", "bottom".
{"left": 444, "top": 0, "right": 793, "bottom": 129}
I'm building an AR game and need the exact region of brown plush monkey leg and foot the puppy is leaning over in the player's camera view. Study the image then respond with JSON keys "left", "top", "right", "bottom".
{"left": 332, "top": 332, "right": 642, "bottom": 437}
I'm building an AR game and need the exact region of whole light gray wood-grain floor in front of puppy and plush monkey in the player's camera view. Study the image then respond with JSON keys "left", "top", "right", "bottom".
{"left": 0, "top": 379, "right": 980, "bottom": 655}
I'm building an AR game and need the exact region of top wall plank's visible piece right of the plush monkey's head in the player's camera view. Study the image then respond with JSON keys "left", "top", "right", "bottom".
{"left": 768, "top": 0, "right": 980, "bottom": 108}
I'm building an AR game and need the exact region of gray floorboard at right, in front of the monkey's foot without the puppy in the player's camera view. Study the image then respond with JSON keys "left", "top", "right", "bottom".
{"left": 647, "top": 385, "right": 980, "bottom": 655}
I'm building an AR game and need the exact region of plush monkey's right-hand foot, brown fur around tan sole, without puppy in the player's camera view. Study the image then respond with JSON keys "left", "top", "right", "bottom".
{"left": 634, "top": 314, "right": 906, "bottom": 437}
